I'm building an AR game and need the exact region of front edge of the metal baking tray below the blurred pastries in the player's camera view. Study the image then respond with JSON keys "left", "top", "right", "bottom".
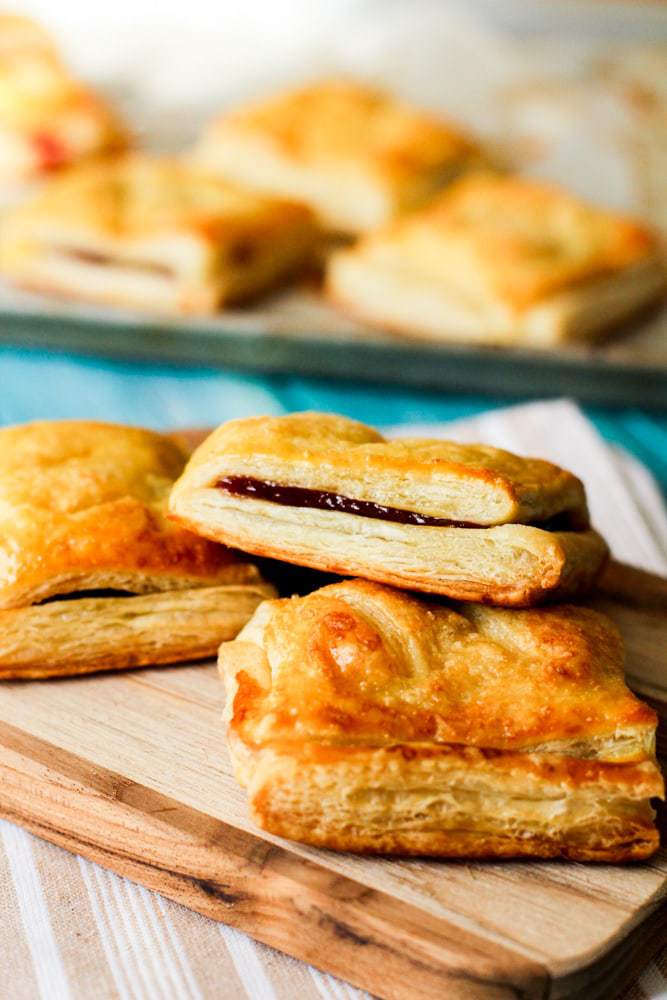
{"left": 0, "top": 288, "right": 667, "bottom": 409}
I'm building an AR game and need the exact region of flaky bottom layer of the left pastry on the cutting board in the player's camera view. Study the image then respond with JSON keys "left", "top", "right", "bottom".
{"left": 0, "top": 583, "right": 275, "bottom": 680}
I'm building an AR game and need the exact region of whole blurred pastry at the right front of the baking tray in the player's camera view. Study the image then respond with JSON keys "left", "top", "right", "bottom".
{"left": 327, "top": 173, "right": 665, "bottom": 347}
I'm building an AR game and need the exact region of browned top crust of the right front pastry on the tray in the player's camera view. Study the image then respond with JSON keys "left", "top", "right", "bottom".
{"left": 360, "top": 173, "right": 656, "bottom": 310}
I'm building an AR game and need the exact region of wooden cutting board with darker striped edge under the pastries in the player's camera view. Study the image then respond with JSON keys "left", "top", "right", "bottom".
{"left": 0, "top": 565, "right": 667, "bottom": 1000}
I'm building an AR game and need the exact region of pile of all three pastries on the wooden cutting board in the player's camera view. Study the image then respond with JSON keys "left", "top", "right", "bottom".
{"left": 0, "top": 413, "right": 663, "bottom": 861}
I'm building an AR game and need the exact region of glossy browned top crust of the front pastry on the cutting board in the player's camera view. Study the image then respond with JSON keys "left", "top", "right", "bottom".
{"left": 220, "top": 580, "right": 656, "bottom": 761}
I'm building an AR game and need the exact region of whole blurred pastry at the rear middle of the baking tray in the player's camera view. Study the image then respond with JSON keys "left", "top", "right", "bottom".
{"left": 192, "top": 80, "right": 482, "bottom": 233}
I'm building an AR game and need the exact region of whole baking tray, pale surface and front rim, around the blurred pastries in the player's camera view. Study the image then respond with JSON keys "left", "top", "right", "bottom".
{"left": 0, "top": 0, "right": 667, "bottom": 407}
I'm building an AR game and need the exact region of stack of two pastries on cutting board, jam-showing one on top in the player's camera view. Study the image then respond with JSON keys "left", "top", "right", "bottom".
{"left": 170, "top": 413, "right": 663, "bottom": 861}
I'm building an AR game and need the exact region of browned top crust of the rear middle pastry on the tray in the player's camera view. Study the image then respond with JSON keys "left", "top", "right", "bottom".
{"left": 200, "top": 80, "right": 477, "bottom": 183}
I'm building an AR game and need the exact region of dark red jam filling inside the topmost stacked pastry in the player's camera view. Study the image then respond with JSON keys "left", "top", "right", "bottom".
{"left": 215, "top": 476, "right": 572, "bottom": 531}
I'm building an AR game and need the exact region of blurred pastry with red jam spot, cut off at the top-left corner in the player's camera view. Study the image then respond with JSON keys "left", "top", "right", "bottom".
{"left": 0, "top": 15, "right": 127, "bottom": 200}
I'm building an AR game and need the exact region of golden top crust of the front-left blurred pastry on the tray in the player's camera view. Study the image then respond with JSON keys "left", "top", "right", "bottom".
{"left": 1, "top": 155, "right": 310, "bottom": 243}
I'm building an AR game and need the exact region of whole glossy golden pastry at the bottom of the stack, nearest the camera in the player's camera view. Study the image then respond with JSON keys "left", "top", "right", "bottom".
{"left": 219, "top": 580, "right": 663, "bottom": 862}
